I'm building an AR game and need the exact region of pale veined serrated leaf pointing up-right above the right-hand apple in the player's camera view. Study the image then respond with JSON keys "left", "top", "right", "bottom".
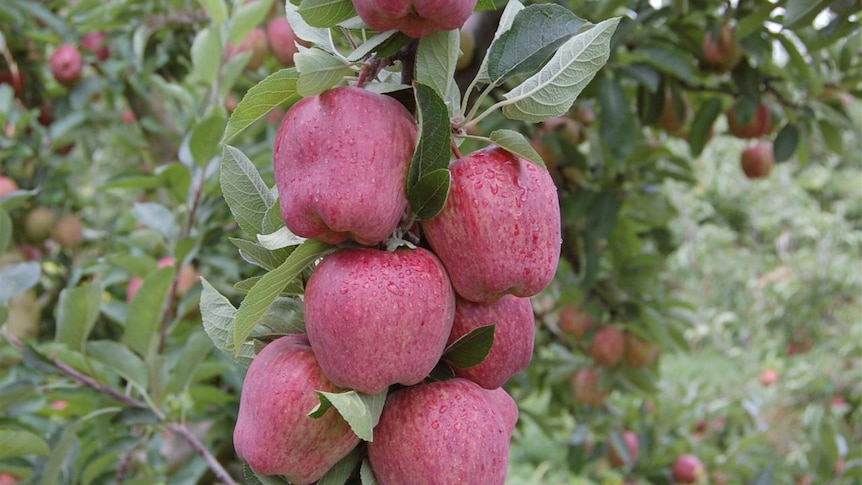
{"left": 503, "top": 17, "right": 620, "bottom": 122}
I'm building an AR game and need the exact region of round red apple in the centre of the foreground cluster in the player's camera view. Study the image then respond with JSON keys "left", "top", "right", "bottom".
{"left": 305, "top": 248, "right": 455, "bottom": 394}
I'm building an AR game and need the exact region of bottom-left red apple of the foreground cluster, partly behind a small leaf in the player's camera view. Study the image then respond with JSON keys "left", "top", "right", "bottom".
{"left": 233, "top": 334, "right": 359, "bottom": 485}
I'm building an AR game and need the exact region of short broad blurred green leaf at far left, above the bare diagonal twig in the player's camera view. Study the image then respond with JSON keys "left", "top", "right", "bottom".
{"left": 55, "top": 283, "right": 102, "bottom": 350}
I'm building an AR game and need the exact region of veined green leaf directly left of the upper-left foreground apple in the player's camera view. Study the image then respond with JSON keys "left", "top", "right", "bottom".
{"left": 220, "top": 145, "right": 275, "bottom": 234}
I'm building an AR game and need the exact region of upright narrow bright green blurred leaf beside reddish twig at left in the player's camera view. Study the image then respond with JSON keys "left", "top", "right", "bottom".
{"left": 124, "top": 266, "right": 176, "bottom": 357}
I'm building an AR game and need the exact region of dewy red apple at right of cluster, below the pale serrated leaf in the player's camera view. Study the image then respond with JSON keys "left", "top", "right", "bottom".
{"left": 422, "top": 147, "right": 562, "bottom": 303}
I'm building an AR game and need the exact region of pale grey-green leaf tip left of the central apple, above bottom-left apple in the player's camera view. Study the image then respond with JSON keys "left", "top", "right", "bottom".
{"left": 201, "top": 278, "right": 255, "bottom": 367}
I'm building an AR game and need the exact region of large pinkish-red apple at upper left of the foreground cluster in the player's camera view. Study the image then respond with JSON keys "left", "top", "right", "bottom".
{"left": 273, "top": 87, "right": 417, "bottom": 245}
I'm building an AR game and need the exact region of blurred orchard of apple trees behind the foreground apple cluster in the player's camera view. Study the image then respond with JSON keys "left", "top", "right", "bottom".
{"left": 0, "top": 0, "right": 862, "bottom": 484}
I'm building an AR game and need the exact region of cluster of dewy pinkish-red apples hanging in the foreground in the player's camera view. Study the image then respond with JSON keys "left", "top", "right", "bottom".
{"left": 234, "top": 79, "right": 561, "bottom": 485}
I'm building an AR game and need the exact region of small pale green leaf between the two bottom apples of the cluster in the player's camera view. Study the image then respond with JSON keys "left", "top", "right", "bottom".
{"left": 308, "top": 391, "right": 387, "bottom": 441}
